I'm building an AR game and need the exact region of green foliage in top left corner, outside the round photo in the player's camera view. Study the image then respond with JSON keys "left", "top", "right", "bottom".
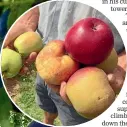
{"left": 0, "top": 0, "right": 47, "bottom": 28}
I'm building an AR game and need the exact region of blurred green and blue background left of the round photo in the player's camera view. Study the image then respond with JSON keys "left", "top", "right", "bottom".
{"left": 0, "top": 0, "right": 46, "bottom": 127}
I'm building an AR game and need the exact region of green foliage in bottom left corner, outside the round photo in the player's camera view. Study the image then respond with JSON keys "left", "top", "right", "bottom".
{"left": 0, "top": 88, "right": 32, "bottom": 127}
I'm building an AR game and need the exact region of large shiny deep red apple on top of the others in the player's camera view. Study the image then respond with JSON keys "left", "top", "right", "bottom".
{"left": 65, "top": 18, "right": 114, "bottom": 65}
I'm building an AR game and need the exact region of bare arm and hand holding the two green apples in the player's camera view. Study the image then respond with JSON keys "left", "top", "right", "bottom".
{"left": 4, "top": 7, "right": 39, "bottom": 74}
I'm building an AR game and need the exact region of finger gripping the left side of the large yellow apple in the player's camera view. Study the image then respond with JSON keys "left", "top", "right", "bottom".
{"left": 60, "top": 82, "right": 72, "bottom": 105}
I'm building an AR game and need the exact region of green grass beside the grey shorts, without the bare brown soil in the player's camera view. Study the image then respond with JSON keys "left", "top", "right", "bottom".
{"left": 15, "top": 66, "right": 61, "bottom": 126}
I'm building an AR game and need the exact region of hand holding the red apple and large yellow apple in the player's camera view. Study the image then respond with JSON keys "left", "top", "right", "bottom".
{"left": 48, "top": 52, "right": 126, "bottom": 105}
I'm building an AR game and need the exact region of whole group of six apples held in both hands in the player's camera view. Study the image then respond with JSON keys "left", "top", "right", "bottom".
{"left": 2, "top": 18, "right": 118, "bottom": 119}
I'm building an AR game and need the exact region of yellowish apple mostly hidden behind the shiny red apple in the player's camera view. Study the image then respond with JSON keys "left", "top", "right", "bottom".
{"left": 97, "top": 48, "right": 118, "bottom": 74}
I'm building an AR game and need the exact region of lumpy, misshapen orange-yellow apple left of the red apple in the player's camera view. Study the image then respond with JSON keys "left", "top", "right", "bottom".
{"left": 36, "top": 40, "right": 79, "bottom": 85}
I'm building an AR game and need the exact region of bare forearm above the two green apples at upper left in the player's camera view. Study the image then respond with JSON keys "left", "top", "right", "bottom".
{"left": 4, "top": 7, "right": 39, "bottom": 47}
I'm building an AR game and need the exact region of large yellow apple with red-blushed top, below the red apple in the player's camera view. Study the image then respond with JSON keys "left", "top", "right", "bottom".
{"left": 66, "top": 67, "right": 115, "bottom": 119}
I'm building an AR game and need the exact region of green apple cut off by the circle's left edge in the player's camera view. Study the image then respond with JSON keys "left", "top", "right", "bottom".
{"left": 1, "top": 48, "right": 22, "bottom": 78}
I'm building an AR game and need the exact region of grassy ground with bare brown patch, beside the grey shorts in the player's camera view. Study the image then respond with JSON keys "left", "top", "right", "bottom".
{"left": 5, "top": 66, "right": 61, "bottom": 126}
